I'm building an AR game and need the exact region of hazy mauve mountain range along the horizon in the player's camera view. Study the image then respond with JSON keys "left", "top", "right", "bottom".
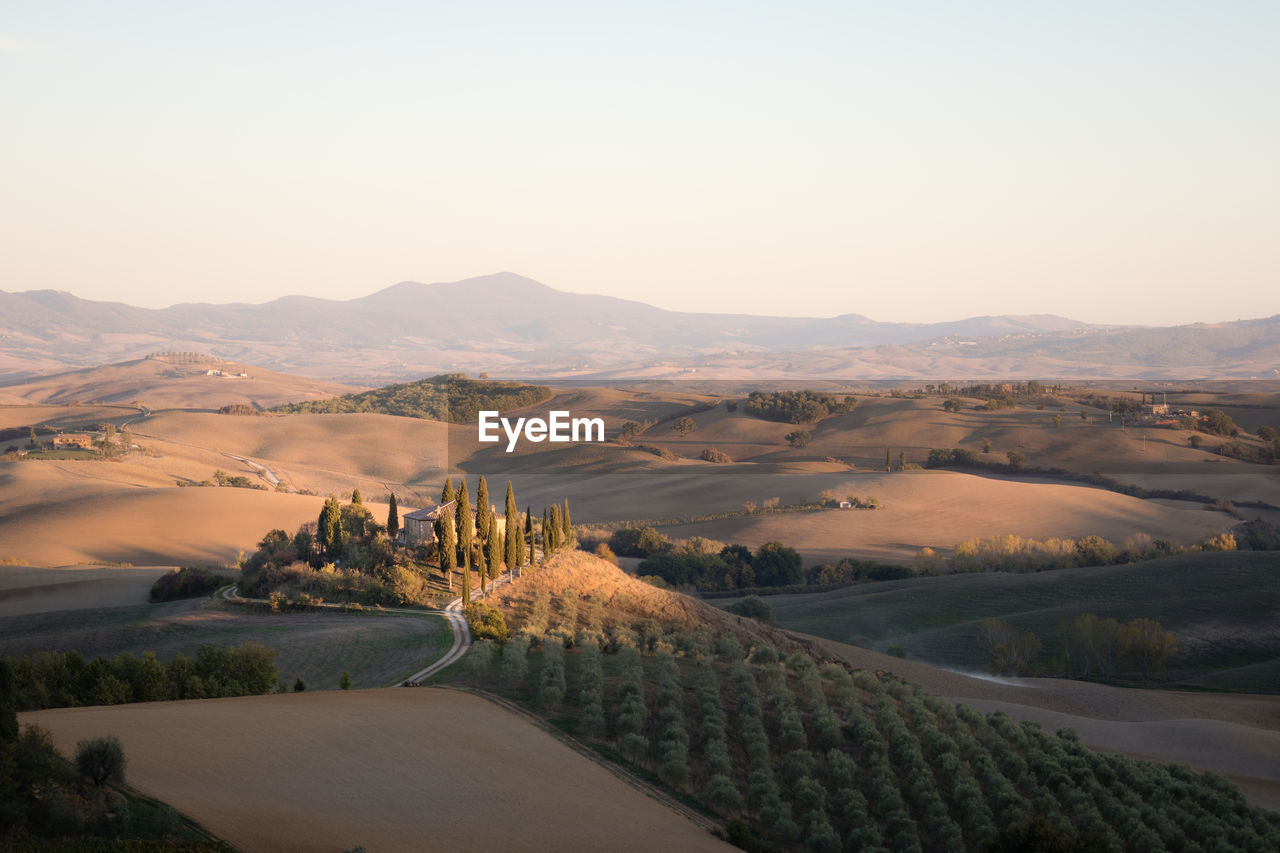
{"left": 0, "top": 273, "right": 1280, "bottom": 384}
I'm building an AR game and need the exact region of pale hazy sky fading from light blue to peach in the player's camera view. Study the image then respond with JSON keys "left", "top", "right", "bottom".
{"left": 0, "top": 0, "right": 1280, "bottom": 324}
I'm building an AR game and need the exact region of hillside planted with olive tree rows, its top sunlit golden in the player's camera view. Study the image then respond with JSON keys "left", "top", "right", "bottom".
{"left": 439, "top": 553, "right": 1280, "bottom": 850}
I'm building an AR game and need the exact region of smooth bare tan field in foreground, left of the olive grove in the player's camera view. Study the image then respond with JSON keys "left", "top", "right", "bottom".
{"left": 22, "top": 688, "right": 732, "bottom": 852}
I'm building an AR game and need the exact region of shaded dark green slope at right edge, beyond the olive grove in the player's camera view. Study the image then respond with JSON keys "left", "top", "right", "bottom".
{"left": 747, "top": 552, "right": 1280, "bottom": 690}
